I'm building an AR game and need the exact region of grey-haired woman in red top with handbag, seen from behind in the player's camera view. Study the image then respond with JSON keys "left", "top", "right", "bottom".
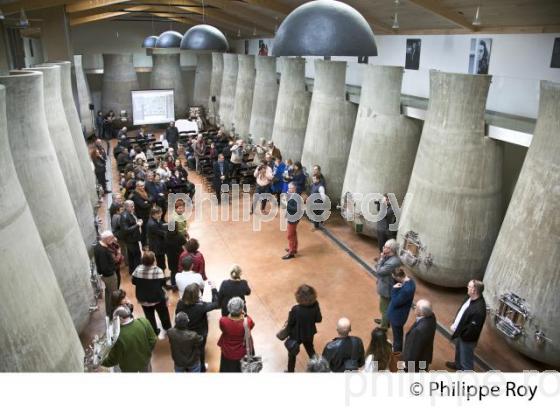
{"left": 218, "top": 297, "right": 255, "bottom": 373}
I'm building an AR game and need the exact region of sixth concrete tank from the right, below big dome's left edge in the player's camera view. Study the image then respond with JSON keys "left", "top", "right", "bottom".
{"left": 249, "top": 57, "right": 278, "bottom": 143}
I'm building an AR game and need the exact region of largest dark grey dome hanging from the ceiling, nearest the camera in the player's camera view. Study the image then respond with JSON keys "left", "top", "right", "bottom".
{"left": 272, "top": 0, "right": 377, "bottom": 56}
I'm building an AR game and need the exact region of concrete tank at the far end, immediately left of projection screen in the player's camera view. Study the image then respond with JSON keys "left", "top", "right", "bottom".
{"left": 101, "top": 54, "right": 140, "bottom": 118}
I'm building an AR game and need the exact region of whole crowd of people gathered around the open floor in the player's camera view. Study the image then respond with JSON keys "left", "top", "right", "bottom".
{"left": 92, "top": 116, "right": 485, "bottom": 372}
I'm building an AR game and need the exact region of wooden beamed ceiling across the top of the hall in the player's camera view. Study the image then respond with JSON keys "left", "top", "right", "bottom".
{"left": 0, "top": 0, "right": 560, "bottom": 38}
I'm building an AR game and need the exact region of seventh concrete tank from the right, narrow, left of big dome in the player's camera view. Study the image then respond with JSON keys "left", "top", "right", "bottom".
{"left": 233, "top": 55, "right": 255, "bottom": 140}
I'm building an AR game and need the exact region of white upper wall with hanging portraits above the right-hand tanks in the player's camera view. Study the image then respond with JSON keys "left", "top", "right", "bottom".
{"left": 233, "top": 33, "right": 560, "bottom": 118}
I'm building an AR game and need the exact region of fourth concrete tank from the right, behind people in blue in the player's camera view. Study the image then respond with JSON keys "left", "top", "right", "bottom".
{"left": 301, "top": 60, "right": 357, "bottom": 206}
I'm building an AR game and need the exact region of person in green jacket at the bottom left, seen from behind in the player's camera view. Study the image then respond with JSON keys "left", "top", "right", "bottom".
{"left": 102, "top": 306, "right": 157, "bottom": 373}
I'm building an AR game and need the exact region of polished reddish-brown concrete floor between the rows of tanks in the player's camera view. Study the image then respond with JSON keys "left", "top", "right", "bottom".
{"left": 82, "top": 143, "right": 542, "bottom": 372}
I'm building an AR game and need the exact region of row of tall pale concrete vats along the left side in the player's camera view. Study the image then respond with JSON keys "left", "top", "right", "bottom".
{"left": 0, "top": 62, "right": 97, "bottom": 371}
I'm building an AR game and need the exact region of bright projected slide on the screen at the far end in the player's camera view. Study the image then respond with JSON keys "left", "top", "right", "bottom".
{"left": 132, "top": 90, "right": 175, "bottom": 125}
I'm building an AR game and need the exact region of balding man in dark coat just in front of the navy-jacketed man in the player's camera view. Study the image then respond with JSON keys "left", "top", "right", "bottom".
{"left": 402, "top": 299, "right": 436, "bottom": 372}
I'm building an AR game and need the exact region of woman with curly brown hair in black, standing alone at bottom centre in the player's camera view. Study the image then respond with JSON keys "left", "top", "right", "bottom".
{"left": 286, "top": 285, "right": 323, "bottom": 373}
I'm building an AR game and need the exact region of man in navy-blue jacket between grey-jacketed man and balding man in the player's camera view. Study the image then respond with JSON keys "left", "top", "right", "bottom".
{"left": 387, "top": 269, "right": 416, "bottom": 352}
